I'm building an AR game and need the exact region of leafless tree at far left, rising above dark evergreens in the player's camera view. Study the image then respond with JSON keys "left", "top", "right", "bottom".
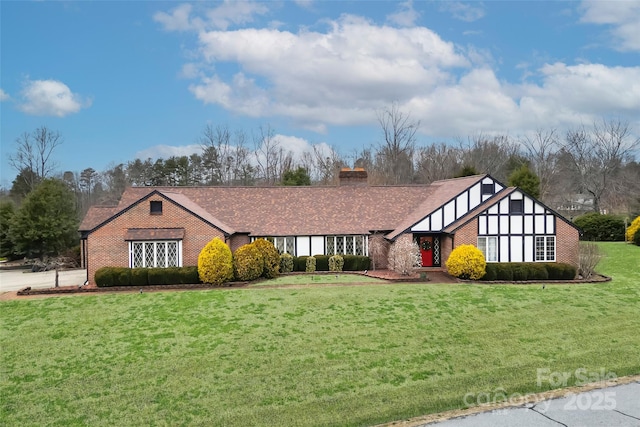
{"left": 9, "top": 126, "right": 63, "bottom": 190}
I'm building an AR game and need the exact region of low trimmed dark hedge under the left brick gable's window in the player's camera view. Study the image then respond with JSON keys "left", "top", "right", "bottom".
{"left": 95, "top": 267, "right": 200, "bottom": 287}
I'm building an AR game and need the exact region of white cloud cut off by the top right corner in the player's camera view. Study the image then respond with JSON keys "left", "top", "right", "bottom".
{"left": 580, "top": 1, "right": 640, "bottom": 51}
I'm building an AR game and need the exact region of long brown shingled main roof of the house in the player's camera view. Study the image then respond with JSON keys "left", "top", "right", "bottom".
{"left": 81, "top": 175, "right": 486, "bottom": 236}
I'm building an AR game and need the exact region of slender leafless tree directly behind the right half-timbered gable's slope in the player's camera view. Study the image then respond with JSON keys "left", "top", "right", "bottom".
{"left": 520, "top": 129, "right": 560, "bottom": 201}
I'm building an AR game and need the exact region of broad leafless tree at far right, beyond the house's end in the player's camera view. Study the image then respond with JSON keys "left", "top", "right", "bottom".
{"left": 563, "top": 119, "right": 640, "bottom": 212}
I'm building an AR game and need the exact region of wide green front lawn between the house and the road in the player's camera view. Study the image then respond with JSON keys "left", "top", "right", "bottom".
{"left": 0, "top": 244, "right": 640, "bottom": 426}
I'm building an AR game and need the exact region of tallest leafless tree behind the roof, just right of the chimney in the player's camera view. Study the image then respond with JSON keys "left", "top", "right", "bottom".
{"left": 376, "top": 102, "right": 420, "bottom": 184}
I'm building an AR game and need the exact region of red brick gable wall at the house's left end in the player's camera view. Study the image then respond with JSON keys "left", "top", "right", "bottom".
{"left": 87, "top": 195, "right": 224, "bottom": 283}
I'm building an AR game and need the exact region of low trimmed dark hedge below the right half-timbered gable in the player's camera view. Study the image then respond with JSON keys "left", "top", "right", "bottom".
{"left": 480, "top": 262, "right": 576, "bottom": 282}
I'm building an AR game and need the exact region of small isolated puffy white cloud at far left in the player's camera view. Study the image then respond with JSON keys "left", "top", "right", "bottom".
{"left": 18, "top": 80, "right": 91, "bottom": 117}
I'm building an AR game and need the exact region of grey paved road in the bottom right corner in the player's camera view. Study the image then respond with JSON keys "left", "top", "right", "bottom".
{"left": 419, "top": 382, "right": 640, "bottom": 427}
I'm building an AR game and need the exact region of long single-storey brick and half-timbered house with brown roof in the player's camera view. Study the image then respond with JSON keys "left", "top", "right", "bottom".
{"left": 80, "top": 169, "right": 579, "bottom": 281}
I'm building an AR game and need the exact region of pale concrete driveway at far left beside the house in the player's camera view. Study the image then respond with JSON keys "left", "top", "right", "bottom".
{"left": 0, "top": 270, "right": 87, "bottom": 292}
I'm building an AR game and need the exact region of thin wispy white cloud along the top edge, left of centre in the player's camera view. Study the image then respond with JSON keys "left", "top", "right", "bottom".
{"left": 153, "top": 0, "right": 269, "bottom": 31}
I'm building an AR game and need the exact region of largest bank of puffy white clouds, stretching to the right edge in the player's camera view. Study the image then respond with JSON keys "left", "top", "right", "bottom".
{"left": 166, "top": 7, "right": 640, "bottom": 137}
